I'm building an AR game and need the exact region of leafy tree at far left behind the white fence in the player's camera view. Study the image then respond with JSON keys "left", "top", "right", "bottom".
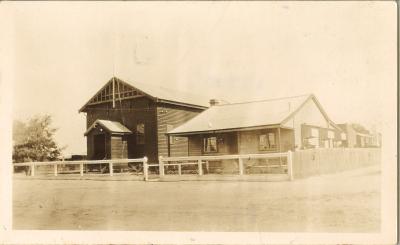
{"left": 13, "top": 115, "right": 63, "bottom": 162}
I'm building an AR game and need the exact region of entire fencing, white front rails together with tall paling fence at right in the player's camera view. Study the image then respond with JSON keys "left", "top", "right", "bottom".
{"left": 13, "top": 148, "right": 381, "bottom": 181}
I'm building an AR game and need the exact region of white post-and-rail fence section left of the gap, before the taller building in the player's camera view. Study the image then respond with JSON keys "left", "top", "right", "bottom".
{"left": 13, "top": 157, "right": 147, "bottom": 176}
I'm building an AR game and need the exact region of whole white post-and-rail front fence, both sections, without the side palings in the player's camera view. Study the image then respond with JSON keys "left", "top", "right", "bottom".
{"left": 13, "top": 151, "right": 293, "bottom": 181}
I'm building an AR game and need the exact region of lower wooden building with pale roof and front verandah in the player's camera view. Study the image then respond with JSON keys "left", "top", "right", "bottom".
{"left": 168, "top": 95, "right": 345, "bottom": 155}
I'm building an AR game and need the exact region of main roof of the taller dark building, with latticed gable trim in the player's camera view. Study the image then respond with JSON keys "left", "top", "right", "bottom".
{"left": 79, "top": 77, "right": 209, "bottom": 112}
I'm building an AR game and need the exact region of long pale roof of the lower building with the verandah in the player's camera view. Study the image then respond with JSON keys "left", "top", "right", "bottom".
{"left": 168, "top": 94, "right": 338, "bottom": 135}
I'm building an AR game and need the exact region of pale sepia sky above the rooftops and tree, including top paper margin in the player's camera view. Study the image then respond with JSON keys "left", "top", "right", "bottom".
{"left": 9, "top": 1, "right": 397, "bottom": 154}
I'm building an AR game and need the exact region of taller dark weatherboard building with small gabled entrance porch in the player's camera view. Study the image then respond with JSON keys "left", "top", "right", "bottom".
{"left": 79, "top": 77, "right": 208, "bottom": 162}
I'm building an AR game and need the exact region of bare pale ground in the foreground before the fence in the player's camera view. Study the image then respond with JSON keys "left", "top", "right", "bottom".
{"left": 13, "top": 166, "right": 380, "bottom": 232}
